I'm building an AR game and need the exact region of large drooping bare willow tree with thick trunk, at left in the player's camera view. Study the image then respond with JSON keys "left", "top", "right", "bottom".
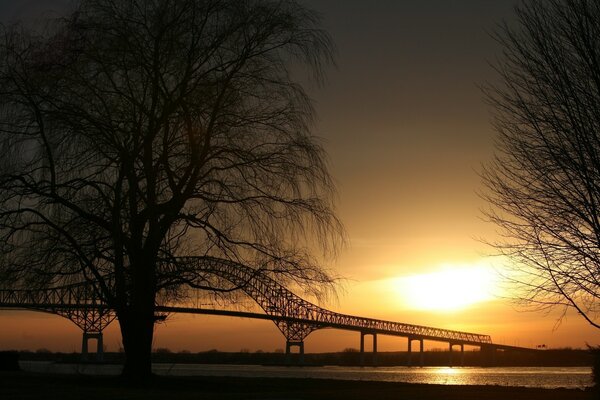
{"left": 0, "top": 0, "right": 343, "bottom": 378}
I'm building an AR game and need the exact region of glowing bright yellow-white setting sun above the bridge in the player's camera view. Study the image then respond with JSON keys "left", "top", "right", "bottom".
{"left": 394, "top": 263, "right": 496, "bottom": 312}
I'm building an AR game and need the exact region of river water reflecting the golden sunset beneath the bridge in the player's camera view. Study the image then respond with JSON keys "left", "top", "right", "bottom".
{"left": 20, "top": 361, "right": 593, "bottom": 389}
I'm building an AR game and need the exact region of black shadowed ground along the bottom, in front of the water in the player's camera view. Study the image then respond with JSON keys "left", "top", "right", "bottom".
{"left": 0, "top": 372, "right": 599, "bottom": 400}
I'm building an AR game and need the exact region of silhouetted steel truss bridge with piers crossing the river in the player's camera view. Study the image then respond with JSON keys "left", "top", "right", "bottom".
{"left": 0, "top": 257, "right": 533, "bottom": 365}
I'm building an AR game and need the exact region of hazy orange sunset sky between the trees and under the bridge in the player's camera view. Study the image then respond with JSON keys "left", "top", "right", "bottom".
{"left": 0, "top": 0, "right": 600, "bottom": 352}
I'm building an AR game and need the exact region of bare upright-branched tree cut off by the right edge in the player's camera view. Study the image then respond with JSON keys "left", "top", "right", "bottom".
{"left": 483, "top": 0, "right": 600, "bottom": 328}
